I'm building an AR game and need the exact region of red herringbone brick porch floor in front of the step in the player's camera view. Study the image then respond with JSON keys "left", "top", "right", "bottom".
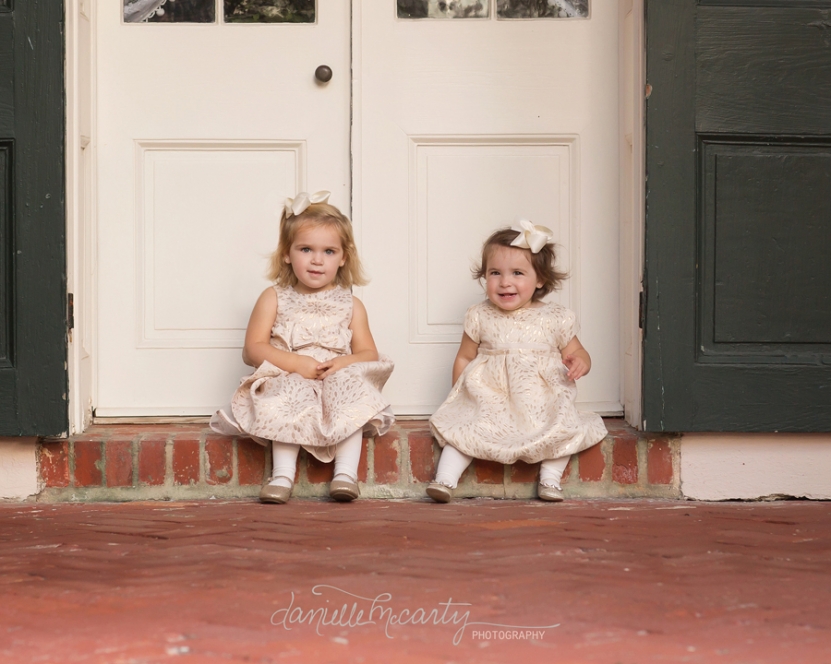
{"left": 0, "top": 499, "right": 831, "bottom": 664}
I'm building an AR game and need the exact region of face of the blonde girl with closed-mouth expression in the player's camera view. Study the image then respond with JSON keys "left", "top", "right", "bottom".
{"left": 285, "top": 223, "right": 346, "bottom": 294}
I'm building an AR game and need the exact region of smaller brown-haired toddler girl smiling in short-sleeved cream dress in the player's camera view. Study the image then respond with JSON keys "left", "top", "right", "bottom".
{"left": 427, "top": 220, "right": 606, "bottom": 503}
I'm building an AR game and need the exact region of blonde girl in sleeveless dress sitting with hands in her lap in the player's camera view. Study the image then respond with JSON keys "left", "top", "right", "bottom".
{"left": 211, "top": 192, "right": 394, "bottom": 503}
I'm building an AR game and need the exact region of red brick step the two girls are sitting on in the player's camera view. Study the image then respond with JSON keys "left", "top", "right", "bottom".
{"left": 38, "top": 419, "right": 681, "bottom": 502}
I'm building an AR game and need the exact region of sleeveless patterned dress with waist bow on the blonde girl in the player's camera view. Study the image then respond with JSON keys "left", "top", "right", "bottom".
{"left": 210, "top": 286, "right": 395, "bottom": 461}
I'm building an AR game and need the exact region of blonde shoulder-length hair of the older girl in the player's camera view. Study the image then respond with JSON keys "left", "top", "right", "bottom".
{"left": 268, "top": 203, "right": 369, "bottom": 288}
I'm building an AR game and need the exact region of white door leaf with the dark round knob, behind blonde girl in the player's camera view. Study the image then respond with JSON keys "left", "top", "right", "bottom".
{"left": 96, "top": 0, "right": 350, "bottom": 416}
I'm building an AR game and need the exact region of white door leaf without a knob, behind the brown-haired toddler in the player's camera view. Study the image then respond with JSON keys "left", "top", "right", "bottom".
{"left": 355, "top": 0, "right": 622, "bottom": 415}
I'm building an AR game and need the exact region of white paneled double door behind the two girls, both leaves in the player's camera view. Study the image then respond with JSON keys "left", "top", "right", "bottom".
{"left": 94, "top": 0, "right": 621, "bottom": 417}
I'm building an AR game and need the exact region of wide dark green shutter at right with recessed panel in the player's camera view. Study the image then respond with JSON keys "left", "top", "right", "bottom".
{"left": 643, "top": 0, "right": 831, "bottom": 431}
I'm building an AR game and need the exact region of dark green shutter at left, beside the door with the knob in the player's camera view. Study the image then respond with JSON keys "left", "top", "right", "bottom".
{"left": 0, "top": 0, "right": 67, "bottom": 436}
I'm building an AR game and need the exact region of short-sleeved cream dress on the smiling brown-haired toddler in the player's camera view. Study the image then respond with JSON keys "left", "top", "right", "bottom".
{"left": 430, "top": 300, "right": 606, "bottom": 464}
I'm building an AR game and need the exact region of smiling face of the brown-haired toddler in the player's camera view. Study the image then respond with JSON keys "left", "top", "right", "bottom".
{"left": 485, "top": 246, "right": 542, "bottom": 311}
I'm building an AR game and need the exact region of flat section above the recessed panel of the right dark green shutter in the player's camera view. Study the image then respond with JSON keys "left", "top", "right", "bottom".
{"left": 695, "top": 6, "right": 831, "bottom": 136}
